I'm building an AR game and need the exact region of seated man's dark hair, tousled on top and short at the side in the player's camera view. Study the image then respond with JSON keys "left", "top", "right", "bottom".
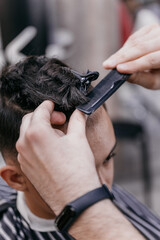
{"left": 0, "top": 56, "right": 87, "bottom": 157}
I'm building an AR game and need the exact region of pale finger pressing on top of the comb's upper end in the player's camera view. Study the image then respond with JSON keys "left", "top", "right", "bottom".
{"left": 117, "top": 51, "right": 160, "bottom": 73}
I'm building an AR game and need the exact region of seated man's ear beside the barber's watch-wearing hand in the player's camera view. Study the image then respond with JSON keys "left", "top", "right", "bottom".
{"left": 0, "top": 165, "right": 27, "bottom": 191}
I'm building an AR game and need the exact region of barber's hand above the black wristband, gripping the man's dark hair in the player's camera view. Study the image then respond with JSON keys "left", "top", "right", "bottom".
{"left": 16, "top": 101, "right": 100, "bottom": 213}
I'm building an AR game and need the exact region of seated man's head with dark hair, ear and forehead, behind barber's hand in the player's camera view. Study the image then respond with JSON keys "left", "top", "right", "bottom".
{"left": 0, "top": 57, "right": 115, "bottom": 219}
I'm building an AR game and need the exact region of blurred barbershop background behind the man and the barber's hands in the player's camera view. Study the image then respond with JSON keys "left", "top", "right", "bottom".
{"left": 0, "top": 0, "right": 160, "bottom": 216}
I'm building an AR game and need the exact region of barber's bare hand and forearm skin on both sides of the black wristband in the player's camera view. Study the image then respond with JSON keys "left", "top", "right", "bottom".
{"left": 16, "top": 101, "right": 144, "bottom": 240}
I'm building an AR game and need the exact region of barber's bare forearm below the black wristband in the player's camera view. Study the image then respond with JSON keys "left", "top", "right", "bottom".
{"left": 69, "top": 200, "right": 145, "bottom": 240}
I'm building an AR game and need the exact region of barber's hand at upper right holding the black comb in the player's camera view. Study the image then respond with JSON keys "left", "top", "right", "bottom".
{"left": 103, "top": 24, "right": 160, "bottom": 89}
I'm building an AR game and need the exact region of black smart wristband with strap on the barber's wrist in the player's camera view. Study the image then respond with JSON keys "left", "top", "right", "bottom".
{"left": 55, "top": 184, "right": 114, "bottom": 232}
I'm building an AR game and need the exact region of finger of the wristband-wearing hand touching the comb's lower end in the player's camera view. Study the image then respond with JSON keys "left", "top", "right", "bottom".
{"left": 67, "top": 109, "right": 87, "bottom": 136}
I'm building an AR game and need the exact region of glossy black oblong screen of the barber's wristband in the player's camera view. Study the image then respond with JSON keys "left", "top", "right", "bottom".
{"left": 55, "top": 205, "right": 76, "bottom": 231}
